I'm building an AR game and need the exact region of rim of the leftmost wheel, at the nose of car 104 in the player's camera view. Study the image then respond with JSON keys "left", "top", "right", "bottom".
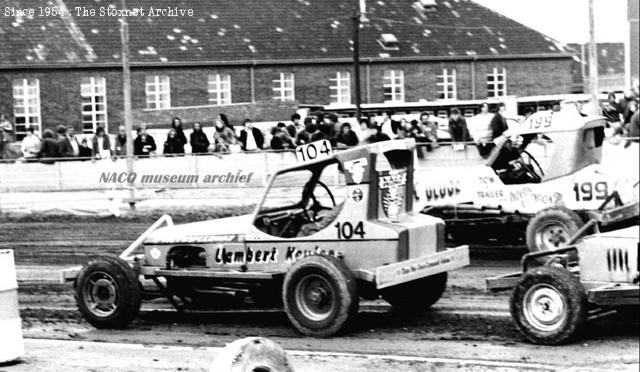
{"left": 82, "top": 271, "right": 118, "bottom": 318}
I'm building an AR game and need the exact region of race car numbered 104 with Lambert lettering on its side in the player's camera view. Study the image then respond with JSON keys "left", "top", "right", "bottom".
{"left": 62, "top": 140, "right": 469, "bottom": 337}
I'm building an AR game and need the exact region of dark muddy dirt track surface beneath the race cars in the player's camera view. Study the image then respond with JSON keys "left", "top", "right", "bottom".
{"left": 6, "top": 217, "right": 640, "bottom": 371}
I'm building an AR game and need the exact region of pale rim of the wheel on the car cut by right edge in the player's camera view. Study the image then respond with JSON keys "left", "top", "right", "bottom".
{"left": 524, "top": 284, "right": 567, "bottom": 332}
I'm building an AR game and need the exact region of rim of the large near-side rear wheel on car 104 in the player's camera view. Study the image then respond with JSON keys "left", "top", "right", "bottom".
{"left": 296, "top": 274, "right": 335, "bottom": 322}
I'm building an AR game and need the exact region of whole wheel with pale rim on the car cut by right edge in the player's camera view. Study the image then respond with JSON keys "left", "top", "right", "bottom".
{"left": 510, "top": 266, "right": 587, "bottom": 345}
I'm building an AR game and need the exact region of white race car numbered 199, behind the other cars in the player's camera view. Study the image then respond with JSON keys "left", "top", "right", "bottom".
{"left": 416, "top": 109, "right": 639, "bottom": 251}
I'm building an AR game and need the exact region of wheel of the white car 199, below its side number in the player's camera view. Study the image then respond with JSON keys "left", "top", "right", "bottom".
{"left": 527, "top": 207, "right": 584, "bottom": 252}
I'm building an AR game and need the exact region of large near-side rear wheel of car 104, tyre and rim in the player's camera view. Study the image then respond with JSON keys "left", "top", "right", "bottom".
{"left": 282, "top": 255, "right": 358, "bottom": 337}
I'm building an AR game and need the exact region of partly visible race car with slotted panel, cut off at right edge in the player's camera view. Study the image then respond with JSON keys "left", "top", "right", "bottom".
{"left": 486, "top": 220, "right": 640, "bottom": 345}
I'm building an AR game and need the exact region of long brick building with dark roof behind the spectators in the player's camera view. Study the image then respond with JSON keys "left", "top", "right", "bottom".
{"left": 0, "top": 0, "right": 574, "bottom": 138}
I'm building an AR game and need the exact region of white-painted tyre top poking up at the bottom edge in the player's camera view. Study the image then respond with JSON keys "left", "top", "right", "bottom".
{"left": 209, "top": 337, "right": 294, "bottom": 372}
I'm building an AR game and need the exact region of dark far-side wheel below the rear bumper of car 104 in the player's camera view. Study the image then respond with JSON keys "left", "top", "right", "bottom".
{"left": 381, "top": 272, "right": 447, "bottom": 312}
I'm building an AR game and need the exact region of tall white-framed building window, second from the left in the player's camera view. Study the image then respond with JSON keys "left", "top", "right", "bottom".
{"left": 80, "top": 77, "right": 107, "bottom": 133}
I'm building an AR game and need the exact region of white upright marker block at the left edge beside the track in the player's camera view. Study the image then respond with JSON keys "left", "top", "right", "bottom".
{"left": 0, "top": 249, "right": 24, "bottom": 363}
